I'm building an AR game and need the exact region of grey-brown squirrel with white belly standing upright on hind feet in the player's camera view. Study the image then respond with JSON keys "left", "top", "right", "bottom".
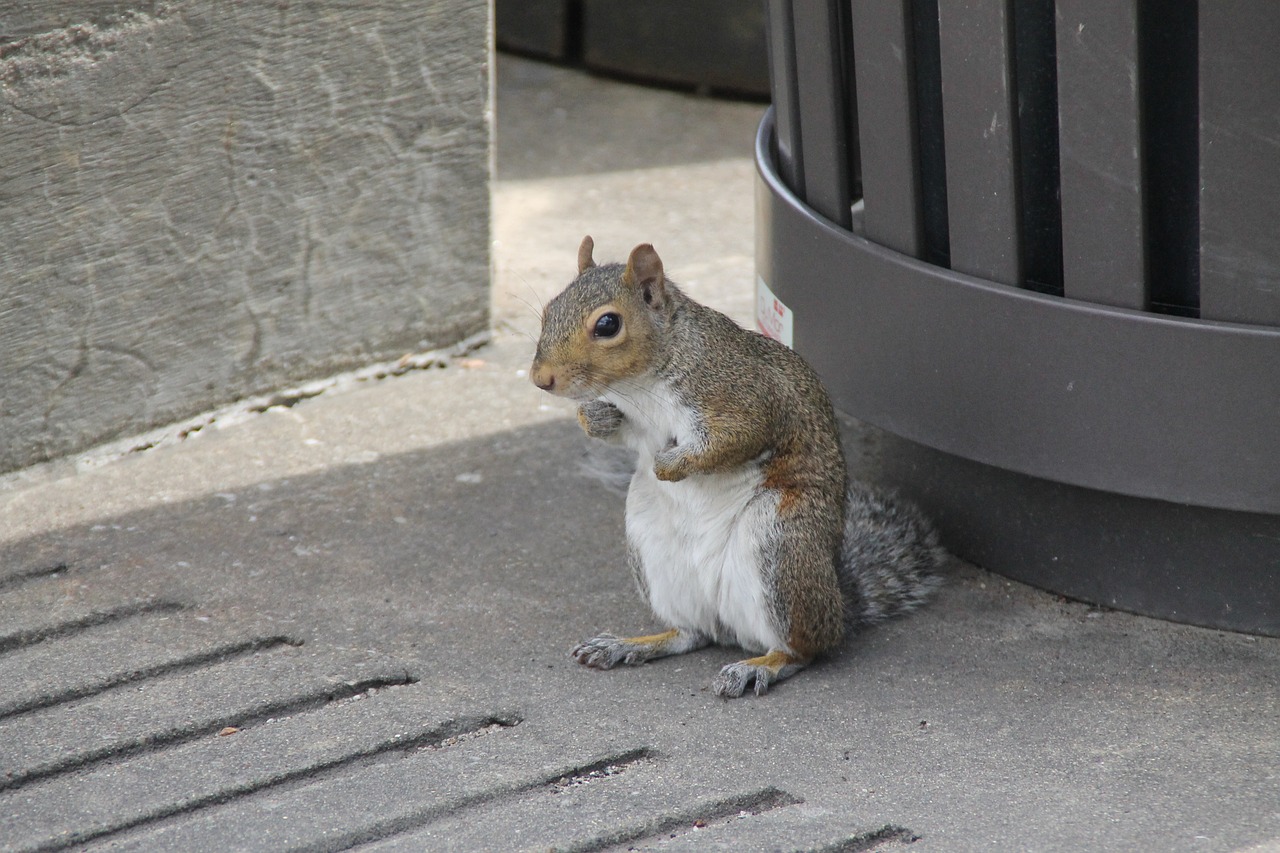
{"left": 530, "top": 237, "right": 946, "bottom": 697}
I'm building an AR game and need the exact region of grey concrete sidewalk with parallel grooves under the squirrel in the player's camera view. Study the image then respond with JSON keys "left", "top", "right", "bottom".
{"left": 0, "top": 58, "right": 1280, "bottom": 850}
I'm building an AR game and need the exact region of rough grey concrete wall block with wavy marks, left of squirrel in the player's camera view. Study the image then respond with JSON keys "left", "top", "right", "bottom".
{"left": 0, "top": 0, "right": 489, "bottom": 471}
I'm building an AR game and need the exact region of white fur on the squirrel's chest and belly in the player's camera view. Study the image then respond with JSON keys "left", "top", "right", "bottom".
{"left": 605, "top": 386, "right": 787, "bottom": 652}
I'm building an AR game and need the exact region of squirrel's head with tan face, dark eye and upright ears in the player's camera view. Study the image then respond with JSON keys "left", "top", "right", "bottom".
{"left": 529, "top": 237, "right": 671, "bottom": 401}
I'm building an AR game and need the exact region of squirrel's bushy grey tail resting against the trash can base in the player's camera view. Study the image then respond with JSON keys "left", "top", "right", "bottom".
{"left": 836, "top": 483, "right": 947, "bottom": 629}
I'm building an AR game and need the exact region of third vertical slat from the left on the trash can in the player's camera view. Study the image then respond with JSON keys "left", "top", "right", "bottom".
{"left": 852, "top": 0, "right": 923, "bottom": 257}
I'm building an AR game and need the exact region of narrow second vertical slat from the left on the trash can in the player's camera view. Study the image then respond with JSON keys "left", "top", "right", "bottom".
{"left": 791, "top": 0, "right": 851, "bottom": 228}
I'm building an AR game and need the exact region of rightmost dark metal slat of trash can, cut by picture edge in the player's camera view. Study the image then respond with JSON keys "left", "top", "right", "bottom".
{"left": 1199, "top": 0, "right": 1280, "bottom": 325}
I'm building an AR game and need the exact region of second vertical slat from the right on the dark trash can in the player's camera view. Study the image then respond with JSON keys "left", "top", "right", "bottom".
{"left": 1057, "top": 0, "right": 1147, "bottom": 310}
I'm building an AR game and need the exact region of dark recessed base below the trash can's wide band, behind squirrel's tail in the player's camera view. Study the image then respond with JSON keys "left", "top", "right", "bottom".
{"left": 846, "top": 421, "right": 1280, "bottom": 637}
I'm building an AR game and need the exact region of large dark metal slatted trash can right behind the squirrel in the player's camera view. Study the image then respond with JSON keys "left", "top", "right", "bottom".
{"left": 756, "top": 0, "right": 1280, "bottom": 627}
